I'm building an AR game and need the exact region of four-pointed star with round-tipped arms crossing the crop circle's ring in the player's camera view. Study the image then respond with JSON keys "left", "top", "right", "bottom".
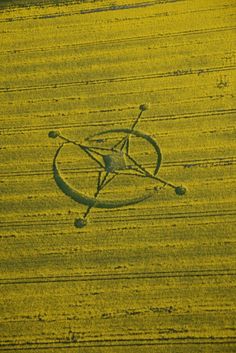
{"left": 48, "top": 104, "right": 186, "bottom": 228}
